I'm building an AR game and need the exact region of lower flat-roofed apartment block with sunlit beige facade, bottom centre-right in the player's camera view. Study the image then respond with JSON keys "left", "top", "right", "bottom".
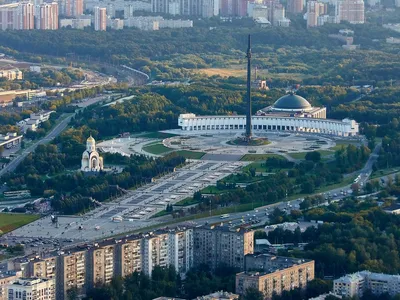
{"left": 236, "top": 255, "right": 314, "bottom": 299}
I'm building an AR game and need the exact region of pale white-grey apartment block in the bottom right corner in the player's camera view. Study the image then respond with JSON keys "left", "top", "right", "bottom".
{"left": 333, "top": 271, "right": 400, "bottom": 297}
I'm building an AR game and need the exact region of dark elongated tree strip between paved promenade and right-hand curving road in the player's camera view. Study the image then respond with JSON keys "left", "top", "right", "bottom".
{"left": 192, "top": 145, "right": 370, "bottom": 211}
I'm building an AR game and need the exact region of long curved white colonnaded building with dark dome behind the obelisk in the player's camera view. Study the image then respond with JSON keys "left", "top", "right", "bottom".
{"left": 178, "top": 94, "right": 359, "bottom": 136}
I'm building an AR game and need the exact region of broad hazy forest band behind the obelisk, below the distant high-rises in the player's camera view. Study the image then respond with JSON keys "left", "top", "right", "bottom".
{"left": 0, "top": 20, "right": 400, "bottom": 87}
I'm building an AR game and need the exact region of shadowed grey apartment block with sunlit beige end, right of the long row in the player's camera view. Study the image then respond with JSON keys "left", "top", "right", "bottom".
{"left": 193, "top": 226, "right": 254, "bottom": 270}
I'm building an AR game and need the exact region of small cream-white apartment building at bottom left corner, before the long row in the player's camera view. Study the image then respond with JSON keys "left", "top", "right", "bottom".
{"left": 7, "top": 278, "right": 56, "bottom": 300}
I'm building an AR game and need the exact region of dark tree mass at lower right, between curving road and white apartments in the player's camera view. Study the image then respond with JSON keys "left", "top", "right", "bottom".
{"left": 268, "top": 199, "right": 400, "bottom": 278}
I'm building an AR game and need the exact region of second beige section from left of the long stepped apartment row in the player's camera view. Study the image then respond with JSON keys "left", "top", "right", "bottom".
{"left": 56, "top": 251, "right": 87, "bottom": 300}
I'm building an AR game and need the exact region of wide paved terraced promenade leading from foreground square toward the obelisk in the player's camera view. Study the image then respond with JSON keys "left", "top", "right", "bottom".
{"left": 8, "top": 161, "right": 247, "bottom": 247}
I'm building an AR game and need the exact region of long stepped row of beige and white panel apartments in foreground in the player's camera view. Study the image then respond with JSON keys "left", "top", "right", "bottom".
{"left": 26, "top": 228, "right": 193, "bottom": 300}
